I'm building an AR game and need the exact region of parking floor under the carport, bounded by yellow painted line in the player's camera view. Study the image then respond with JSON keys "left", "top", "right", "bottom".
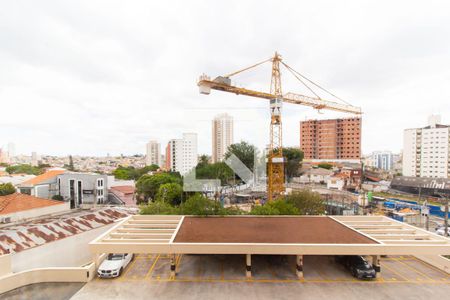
{"left": 96, "top": 254, "right": 450, "bottom": 284}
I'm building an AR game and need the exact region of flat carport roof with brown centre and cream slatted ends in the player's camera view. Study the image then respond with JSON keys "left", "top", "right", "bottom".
{"left": 90, "top": 215, "right": 450, "bottom": 255}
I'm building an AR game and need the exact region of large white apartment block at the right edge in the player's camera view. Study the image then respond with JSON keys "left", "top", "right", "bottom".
{"left": 402, "top": 115, "right": 450, "bottom": 178}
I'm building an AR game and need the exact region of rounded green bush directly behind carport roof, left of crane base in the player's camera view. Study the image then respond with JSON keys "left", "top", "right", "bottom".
{"left": 180, "top": 194, "right": 225, "bottom": 216}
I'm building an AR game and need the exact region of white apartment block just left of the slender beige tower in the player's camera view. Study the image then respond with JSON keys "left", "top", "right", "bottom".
{"left": 166, "top": 133, "right": 198, "bottom": 175}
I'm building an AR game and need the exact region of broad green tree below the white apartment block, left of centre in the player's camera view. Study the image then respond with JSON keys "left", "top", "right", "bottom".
{"left": 136, "top": 173, "right": 182, "bottom": 201}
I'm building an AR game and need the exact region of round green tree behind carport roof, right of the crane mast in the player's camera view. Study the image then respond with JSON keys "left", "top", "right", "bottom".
{"left": 286, "top": 189, "right": 325, "bottom": 215}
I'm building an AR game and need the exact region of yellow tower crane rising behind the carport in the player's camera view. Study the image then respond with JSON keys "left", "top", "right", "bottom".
{"left": 197, "top": 52, "right": 362, "bottom": 201}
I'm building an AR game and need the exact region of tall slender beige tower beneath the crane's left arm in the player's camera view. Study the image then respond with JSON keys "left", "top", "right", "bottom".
{"left": 212, "top": 114, "right": 233, "bottom": 163}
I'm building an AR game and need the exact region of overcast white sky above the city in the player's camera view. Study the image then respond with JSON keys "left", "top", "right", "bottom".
{"left": 0, "top": 0, "right": 450, "bottom": 156}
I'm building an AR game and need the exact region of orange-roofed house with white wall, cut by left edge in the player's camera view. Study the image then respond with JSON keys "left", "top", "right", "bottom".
{"left": 0, "top": 193, "right": 70, "bottom": 223}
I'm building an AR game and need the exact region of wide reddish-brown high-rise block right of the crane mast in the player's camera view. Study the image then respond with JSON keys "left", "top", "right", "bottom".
{"left": 300, "top": 118, "right": 361, "bottom": 160}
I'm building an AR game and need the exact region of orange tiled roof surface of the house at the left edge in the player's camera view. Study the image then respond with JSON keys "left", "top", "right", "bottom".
{"left": 0, "top": 193, "right": 64, "bottom": 215}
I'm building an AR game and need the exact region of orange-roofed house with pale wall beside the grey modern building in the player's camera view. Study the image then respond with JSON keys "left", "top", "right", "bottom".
{"left": 18, "top": 170, "right": 66, "bottom": 199}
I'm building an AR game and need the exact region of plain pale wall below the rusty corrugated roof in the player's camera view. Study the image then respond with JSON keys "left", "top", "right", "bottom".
{"left": 11, "top": 223, "right": 117, "bottom": 272}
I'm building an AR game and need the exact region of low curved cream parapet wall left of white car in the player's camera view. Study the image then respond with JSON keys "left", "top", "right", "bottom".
{"left": 0, "top": 255, "right": 95, "bottom": 294}
